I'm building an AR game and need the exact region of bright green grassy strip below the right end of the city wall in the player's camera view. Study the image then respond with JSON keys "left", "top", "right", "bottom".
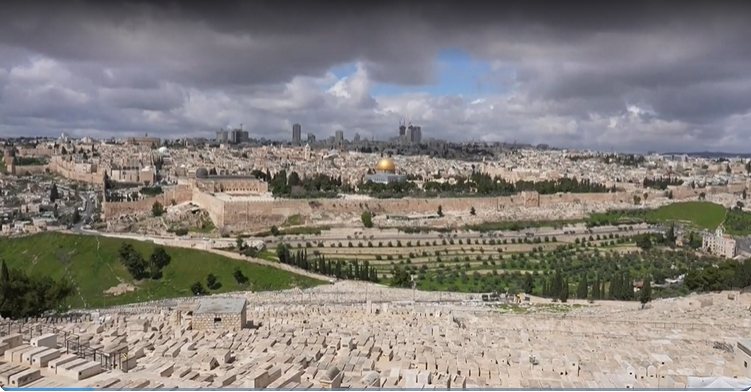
{"left": 587, "top": 201, "right": 727, "bottom": 230}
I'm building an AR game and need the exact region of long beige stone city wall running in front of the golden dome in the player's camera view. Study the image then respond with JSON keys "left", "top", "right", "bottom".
{"left": 98, "top": 184, "right": 745, "bottom": 231}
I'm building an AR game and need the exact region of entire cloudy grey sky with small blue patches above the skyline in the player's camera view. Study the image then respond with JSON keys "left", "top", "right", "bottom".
{"left": 0, "top": 0, "right": 751, "bottom": 152}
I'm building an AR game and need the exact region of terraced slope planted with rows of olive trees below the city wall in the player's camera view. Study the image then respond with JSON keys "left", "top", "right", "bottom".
{"left": 263, "top": 226, "right": 717, "bottom": 298}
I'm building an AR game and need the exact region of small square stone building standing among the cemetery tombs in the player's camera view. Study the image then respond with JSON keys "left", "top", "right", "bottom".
{"left": 191, "top": 298, "right": 248, "bottom": 331}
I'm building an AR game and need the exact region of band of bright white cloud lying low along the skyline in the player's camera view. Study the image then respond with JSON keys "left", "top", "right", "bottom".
{"left": 3, "top": 58, "right": 749, "bottom": 153}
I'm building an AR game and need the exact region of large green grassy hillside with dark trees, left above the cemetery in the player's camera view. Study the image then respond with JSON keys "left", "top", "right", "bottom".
{"left": 0, "top": 233, "right": 323, "bottom": 308}
